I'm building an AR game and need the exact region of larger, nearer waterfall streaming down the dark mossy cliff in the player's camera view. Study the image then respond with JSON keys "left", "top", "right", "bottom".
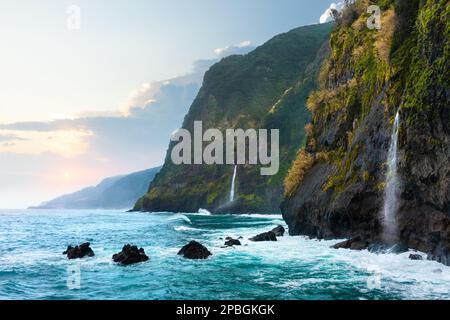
{"left": 383, "top": 112, "right": 400, "bottom": 241}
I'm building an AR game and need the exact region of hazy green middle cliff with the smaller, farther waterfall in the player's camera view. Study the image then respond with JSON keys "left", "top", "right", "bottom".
{"left": 135, "top": 24, "right": 331, "bottom": 213}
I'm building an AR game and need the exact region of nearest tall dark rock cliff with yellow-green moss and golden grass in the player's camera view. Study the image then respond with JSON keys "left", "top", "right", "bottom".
{"left": 281, "top": 0, "right": 450, "bottom": 264}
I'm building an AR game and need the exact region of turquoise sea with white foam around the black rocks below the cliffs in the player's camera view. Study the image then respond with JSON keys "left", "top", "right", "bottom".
{"left": 0, "top": 210, "right": 450, "bottom": 299}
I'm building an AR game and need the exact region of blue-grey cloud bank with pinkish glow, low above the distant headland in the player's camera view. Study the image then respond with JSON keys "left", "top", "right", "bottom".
{"left": 0, "top": 42, "right": 251, "bottom": 207}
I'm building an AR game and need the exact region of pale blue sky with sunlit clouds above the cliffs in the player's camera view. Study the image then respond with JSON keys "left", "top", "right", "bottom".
{"left": 0, "top": 0, "right": 338, "bottom": 208}
